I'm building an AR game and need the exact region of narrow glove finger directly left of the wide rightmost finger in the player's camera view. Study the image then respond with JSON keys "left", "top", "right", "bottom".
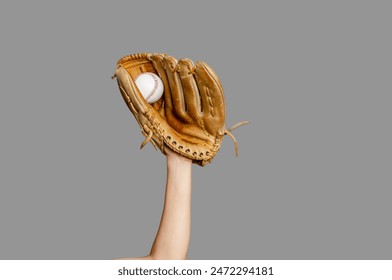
{"left": 177, "top": 58, "right": 201, "bottom": 119}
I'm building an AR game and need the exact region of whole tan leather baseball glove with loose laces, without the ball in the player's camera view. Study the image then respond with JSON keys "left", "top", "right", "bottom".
{"left": 112, "top": 53, "right": 248, "bottom": 166}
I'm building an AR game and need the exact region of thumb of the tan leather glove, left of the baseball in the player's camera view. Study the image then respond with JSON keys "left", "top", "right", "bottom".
{"left": 115, "top": 67, "right": 150, "bottom": 114}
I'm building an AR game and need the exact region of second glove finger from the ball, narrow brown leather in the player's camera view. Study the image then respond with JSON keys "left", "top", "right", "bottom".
{"left": 163, "top": 56, "right": 188, "bottom": 122}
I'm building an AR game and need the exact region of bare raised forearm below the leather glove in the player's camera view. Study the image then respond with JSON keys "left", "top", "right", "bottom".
{"left": 117, "top": 148, "right": 192, "bottom": 260}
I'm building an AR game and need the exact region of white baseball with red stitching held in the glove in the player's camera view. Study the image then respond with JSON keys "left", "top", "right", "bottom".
{"left": 135, "top": 72, "right": 163, "bottom": 104}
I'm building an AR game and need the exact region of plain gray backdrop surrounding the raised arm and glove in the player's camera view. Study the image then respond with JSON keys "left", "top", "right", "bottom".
{"left": 0, "top": 0, "right": 392, "bottom": 259}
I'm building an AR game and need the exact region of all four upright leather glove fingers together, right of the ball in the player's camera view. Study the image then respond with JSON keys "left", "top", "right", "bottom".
{"left": 149, "top": 54, "right": 225, "bottom": 122}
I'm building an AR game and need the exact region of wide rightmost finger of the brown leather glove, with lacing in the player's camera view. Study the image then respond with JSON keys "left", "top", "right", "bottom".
{"left": 195, "top": 62, "right": 225, "bottom": 122}
